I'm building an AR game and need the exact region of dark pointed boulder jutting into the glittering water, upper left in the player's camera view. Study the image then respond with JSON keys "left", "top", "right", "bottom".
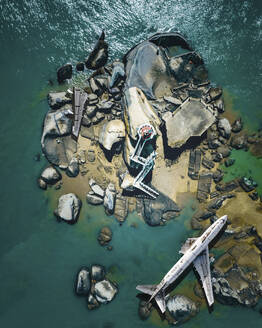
{"left": 85, "top": 31, "right": 108, "bottom": 70}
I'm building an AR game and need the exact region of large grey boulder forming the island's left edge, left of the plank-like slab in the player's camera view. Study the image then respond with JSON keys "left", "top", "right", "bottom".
{"left": 41, "top": 105, "right": 77, "bottom": 168}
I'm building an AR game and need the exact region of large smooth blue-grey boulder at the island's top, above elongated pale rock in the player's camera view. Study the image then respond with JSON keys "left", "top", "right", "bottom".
{"left": 124, "top": 41, "right": 176, "bottom": 99}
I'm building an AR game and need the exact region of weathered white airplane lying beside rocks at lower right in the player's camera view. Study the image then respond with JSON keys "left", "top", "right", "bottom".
{"left": 136, "top": 215, "right": 227, "bottom": 313}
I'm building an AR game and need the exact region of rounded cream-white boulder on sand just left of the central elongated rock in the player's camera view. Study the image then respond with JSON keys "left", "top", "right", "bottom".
{"left": 99, "top": 120, "right": 126, "bottom": 150}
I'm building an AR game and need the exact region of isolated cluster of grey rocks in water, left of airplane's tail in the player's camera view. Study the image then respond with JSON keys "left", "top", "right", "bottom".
{"left": 75, "top": 264, "right": 118, "bottom": 310}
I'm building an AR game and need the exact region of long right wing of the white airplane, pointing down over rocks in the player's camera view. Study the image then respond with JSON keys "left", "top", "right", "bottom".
{"left": 193, "top": 247, "right": 214, "bottom": 306}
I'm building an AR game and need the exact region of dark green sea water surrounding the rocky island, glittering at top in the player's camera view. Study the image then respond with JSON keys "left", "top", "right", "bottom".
{"left": 0, "top": 0, "right": 262, "bottom": 328}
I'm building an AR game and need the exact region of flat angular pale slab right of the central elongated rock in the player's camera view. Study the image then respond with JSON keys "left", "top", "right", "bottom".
{"left": 163, "top": 98, "right": 217, "bottom": 148}
